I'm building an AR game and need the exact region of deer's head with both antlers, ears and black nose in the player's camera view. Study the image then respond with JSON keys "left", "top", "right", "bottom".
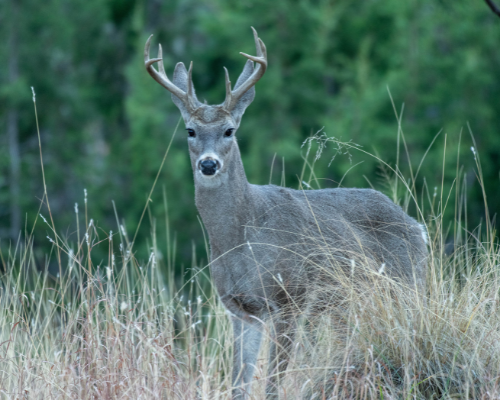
{"left": 144, "top": 28, "right": 267, "bottom": 186}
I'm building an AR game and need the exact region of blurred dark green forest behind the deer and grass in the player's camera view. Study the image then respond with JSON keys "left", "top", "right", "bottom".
{"left": 0, "top": 0, "right": 500, "bottom": 274}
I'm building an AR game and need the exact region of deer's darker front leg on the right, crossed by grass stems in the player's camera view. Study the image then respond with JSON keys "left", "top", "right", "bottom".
{"left": 266, "top": 316, "right": 295, "bottom": 399}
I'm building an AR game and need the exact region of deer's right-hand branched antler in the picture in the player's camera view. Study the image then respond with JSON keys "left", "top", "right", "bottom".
{"left": 223, "top": 27, "right": 267, "bottom": 111}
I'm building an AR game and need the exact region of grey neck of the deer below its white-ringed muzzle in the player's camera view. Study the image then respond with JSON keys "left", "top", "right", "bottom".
{"left": 195, "top": 144, "right": 252, "bottom": 254}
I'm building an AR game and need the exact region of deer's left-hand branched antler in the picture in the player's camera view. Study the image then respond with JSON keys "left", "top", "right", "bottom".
{"left": 144, "top": 35, "right": 197, "bottom": 112}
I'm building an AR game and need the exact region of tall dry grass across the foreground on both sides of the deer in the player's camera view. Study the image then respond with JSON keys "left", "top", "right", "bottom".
{"left": 0, "top": 101, "right": 500, "bottom": 399}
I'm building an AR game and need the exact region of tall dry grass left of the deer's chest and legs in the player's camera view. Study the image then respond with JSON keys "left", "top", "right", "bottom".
{"left": 0, "top": 217, "right": 232, "bottom": 399}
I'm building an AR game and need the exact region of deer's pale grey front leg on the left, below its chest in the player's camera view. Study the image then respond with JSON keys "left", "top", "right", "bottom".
{"left": 232, "top": 316, "right": 263, "bottom": 400}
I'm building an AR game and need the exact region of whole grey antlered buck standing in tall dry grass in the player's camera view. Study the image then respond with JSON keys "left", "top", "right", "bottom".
{"left": 144, "top": 28, "right": 427, "bottom": 399}
